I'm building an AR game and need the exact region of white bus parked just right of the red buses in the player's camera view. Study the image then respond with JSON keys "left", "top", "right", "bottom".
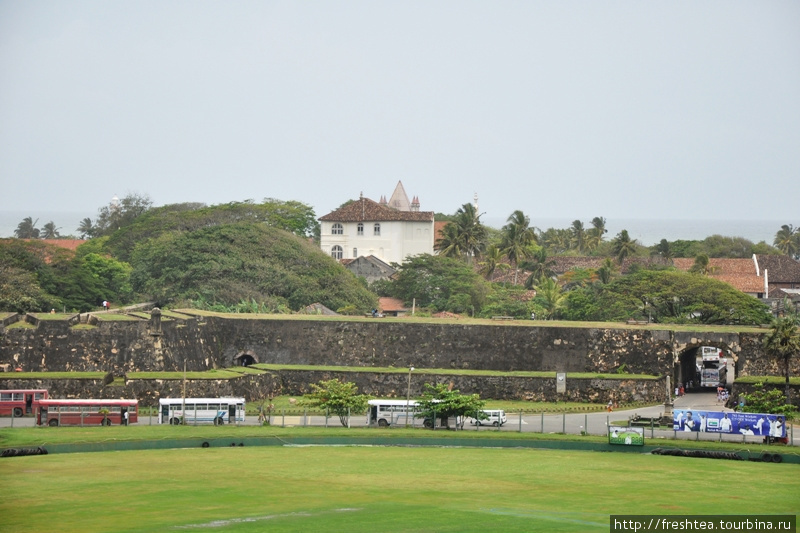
{"left": 158, "top": 398, "right": 244, "bottom": 426}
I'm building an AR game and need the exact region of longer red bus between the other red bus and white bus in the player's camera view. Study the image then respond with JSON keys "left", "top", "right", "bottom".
{"left": 36, "top": 400, "right": 139, "bottom": 427}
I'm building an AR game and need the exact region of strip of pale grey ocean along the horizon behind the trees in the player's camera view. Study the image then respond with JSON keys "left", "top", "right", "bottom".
{"left": 0, "top": 211, "right": 788, "bottom": 246}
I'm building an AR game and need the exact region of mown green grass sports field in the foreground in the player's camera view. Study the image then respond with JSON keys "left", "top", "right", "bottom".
{"left": 0, "top": 446, "right": 800, "bottom": 533}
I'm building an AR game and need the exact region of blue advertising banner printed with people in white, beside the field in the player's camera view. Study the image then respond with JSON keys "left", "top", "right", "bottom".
{"left": 672, "top": 409, "right": 786, "bottom": 439}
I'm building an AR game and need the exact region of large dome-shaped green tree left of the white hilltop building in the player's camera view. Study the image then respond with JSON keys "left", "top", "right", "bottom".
{"left": 131, "top": 222, "right": 377, "bottom": 311}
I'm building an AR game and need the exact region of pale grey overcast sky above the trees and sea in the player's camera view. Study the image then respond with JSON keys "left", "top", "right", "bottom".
{"left": 0, "top": 0, "right": 800, "bottom": 224}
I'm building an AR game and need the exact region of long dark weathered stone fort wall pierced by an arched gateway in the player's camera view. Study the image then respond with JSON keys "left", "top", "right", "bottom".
{"left": 0, "top": 315, "right": 800, "bottom": 399}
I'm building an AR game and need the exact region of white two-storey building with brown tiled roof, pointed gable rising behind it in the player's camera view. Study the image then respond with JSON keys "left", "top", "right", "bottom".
{"left": 319, "top": 182, "right": 434, "bottom": 263}
